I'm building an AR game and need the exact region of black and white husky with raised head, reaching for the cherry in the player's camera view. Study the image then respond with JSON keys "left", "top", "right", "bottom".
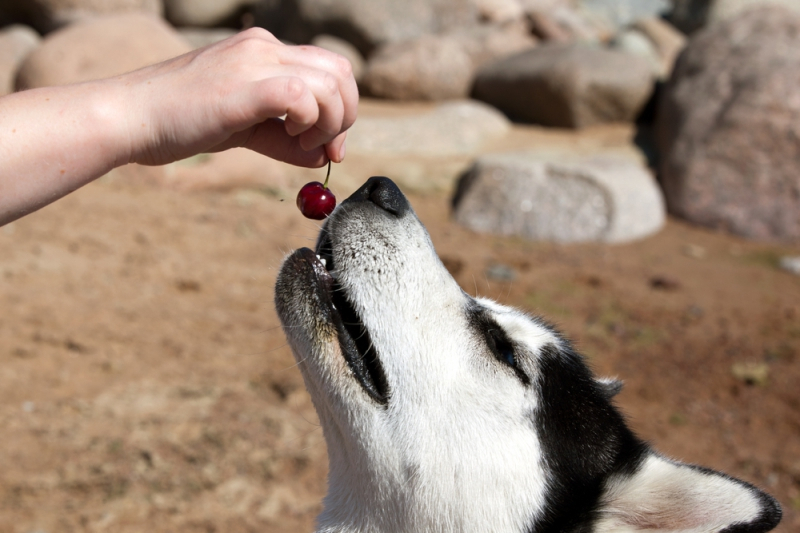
{"left": 275, "top": 177, "right": 781, "bottom": 533}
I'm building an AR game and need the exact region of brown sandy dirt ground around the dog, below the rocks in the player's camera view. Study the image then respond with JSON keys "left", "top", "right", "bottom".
{"left": 0, "top": 115, "right": 800, "bottom": 533}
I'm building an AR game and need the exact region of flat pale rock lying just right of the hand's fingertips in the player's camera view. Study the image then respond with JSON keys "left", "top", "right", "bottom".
{"left": 347, "top": 101, "right": 511, "bottom": 157}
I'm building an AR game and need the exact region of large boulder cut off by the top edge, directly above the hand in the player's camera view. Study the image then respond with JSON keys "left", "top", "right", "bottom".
{"left": 254, "top": 0, "right": 478, "bottom": 57}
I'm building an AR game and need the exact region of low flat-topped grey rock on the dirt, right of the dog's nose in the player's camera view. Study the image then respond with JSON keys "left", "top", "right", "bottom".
{"left": 454, "top": 153, "right": 665, "bottom": 243}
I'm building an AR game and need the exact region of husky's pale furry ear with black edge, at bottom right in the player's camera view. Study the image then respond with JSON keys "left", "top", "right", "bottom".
{"left": 594, "top": 455, "right": 781, "bottom": 533}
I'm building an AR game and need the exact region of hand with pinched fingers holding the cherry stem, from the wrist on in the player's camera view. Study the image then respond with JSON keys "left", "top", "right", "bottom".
{"left": 116, "top": 28, "right": 358, "bottom": 167}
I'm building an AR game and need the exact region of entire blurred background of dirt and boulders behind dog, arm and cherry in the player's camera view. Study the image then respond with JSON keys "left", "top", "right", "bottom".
{"left": 0, "top": 0, "right": 800, "bottom": 533}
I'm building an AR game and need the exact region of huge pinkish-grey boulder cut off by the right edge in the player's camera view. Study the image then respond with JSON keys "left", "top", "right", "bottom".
{"left": 657, "top": 8, "right": 800, "bottom": 241}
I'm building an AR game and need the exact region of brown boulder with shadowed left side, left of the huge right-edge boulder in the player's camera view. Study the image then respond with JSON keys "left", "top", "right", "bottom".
{"left": 472, "top": 44, "right": 653, "bottom": 128}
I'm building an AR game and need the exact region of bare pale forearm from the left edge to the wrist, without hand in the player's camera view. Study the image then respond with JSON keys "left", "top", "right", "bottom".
{"left": 0, "top": 80, "right": 130, "bottom": 225}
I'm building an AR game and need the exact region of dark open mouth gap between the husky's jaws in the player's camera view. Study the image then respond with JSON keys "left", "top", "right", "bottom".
{"left": 308, "top": 230, "right": 389, "bottom": 405}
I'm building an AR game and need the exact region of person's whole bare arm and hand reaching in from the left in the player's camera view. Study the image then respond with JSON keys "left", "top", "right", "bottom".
{"left": 0, "top": 28, "right": 358, "bottom": 225}
